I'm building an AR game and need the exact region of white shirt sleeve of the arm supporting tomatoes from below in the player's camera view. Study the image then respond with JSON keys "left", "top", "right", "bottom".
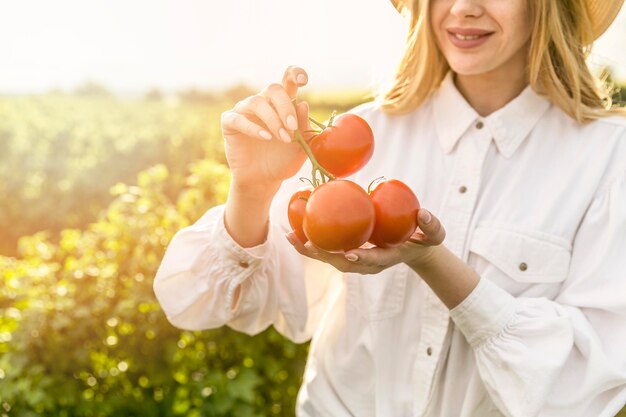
{"left": 450, "top": 170, "right": 626, "bottom": 417}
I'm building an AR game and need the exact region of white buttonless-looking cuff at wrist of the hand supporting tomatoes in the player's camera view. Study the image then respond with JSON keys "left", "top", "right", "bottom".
{"left": 450, "top": 278, "right": 516, "bottom": 348}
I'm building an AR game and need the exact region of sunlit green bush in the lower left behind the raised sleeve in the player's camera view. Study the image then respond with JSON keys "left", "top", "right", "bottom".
{"left": 0, "top": 160, "right": 307, "bottom": 417}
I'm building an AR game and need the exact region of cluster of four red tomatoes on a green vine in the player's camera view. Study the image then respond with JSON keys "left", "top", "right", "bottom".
{"left": 288, "top": 114, "right": 420, "bottom": 251}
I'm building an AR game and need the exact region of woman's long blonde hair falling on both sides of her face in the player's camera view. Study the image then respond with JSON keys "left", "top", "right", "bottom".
{"left": 377, "top": 0, "right": 626, "bottom": 123}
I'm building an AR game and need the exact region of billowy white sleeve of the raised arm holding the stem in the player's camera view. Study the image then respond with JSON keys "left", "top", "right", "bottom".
{"left": 154, "top": 175, "right": 337, "bottom": 343}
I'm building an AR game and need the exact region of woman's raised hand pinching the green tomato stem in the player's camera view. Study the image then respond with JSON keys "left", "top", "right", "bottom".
{"left": 221, "top": 66, "right": 311, "bottom": 189}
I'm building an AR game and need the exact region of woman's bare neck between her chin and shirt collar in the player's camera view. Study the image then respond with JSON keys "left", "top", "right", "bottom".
{"left": 454, "top": 65, "right": 528, "bottom": 116}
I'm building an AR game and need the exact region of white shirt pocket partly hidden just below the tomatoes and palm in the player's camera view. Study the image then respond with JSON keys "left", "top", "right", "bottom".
{"left": 346, "top": 264, "right": 409, "bottom": 320}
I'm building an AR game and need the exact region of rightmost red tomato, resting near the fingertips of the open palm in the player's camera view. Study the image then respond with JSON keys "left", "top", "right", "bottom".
{"left": 369, "top": 180, "right": 420, "bottom": 248}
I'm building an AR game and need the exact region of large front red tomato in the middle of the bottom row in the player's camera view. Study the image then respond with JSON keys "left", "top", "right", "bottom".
{"left": 303, "top": 180, "right": 375, "bottom": 251}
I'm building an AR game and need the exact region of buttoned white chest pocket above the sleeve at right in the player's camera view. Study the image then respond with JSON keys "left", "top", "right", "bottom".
{"left": 470, "top": 225, "right": 571, "bottom": 284}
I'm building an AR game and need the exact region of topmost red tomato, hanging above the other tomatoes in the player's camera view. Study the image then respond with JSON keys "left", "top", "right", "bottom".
{"left": 309, "top": 113, "right": 374, "bottom": 178}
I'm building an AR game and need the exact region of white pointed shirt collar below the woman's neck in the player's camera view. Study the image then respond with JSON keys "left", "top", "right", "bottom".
{"left": 433, "top": 72, "right": 550, "bottom": 158}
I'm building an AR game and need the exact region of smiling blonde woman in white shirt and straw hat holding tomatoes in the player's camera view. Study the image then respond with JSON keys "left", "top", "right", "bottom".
{"left": 155, "top": 0, "right": 626, "bottom": 417}
